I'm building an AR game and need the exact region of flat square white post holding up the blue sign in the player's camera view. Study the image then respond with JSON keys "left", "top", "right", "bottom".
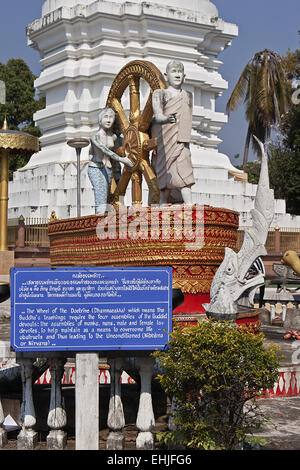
{"left": 75, "top": 353, "right": 99, "bottom": 450}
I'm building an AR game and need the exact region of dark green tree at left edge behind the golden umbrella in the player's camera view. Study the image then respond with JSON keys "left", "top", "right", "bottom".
{"left": 0, "top": 59, "right": 45, "bottom": 179}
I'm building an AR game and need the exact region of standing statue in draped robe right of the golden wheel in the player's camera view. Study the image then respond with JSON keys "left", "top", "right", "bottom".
{"left": 152, "top": 61, "right": 195, "bottom": 204}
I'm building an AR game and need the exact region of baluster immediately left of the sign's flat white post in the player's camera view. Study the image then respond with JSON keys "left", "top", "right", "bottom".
{"left": 47, "top": 358, "right": 67, "bottom": 450}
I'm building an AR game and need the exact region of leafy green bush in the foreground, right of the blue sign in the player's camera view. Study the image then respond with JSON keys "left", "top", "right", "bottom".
{"left": 154, "top": 320, "right": 279, "bottom": 450}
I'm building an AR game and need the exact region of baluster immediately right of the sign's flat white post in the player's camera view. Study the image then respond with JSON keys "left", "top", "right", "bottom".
{"left": 106, "top": 358, "right": 125, "bottom": 450}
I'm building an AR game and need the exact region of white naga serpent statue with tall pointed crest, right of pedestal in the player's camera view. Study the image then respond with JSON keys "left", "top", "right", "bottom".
{"left": 204, "top": 137, "right": 274, "bottom": 320}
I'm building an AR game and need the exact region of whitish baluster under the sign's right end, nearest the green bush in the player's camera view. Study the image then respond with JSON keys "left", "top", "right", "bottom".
{"left": 136, "top": 357, "right": 155, "bottom": 450}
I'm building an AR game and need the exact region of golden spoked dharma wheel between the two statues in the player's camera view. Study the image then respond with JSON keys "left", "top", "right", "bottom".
{"left": 106, "top": 60, "right": 167, "bottom": 205}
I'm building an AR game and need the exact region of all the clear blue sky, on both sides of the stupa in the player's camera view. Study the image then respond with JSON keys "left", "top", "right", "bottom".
{"left": 0, "top": 0, "right": 300, "bottom": 164}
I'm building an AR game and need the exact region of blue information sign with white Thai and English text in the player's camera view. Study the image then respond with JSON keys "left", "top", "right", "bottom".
{"left": 11, "top": 267, "right": 172, "bottom": 352}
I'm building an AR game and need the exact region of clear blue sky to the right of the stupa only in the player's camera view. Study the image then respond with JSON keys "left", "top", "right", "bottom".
{"left": 213, "top": 0, "right": 300, "bottom": 164}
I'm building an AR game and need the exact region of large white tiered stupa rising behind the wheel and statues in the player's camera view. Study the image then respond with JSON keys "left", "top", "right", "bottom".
{"left": 9, "top": 0, "right": 299, "bottom": 226}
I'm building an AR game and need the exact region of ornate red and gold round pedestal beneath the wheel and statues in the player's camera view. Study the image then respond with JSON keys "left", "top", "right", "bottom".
{"left": 48, "top": 206, "right": 238, "bottom": 294}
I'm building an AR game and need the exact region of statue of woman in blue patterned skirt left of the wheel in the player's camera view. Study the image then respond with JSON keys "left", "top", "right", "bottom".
{"left": 88, "top": 108, "right": 133, "bottom": 214}
